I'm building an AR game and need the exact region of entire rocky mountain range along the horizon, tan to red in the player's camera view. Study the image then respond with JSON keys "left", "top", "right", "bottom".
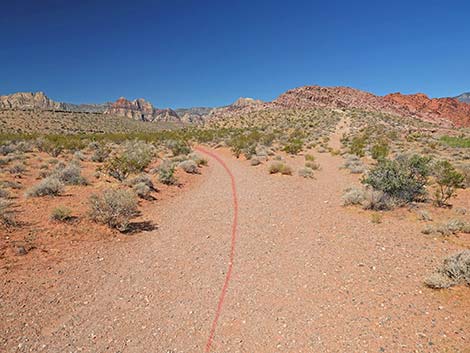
{"left": 0, "top": 86, "right": 470, "bottom": 127}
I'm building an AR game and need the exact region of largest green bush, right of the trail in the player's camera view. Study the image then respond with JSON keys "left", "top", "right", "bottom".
{"left": 363, "top": 155, "right": 430, "bottom": 202}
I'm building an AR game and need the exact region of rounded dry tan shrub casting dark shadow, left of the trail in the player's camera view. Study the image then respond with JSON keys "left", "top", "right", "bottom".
{"left": 89, "top": 189, "right": 139, "bottom": 232}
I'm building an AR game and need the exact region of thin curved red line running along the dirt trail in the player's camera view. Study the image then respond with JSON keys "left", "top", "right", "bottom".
{"left": 196, "top": 147, "right": 238, "bottom": 353}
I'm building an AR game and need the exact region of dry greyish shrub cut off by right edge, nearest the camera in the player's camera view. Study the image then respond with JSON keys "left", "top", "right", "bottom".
{"left": 424, "top": 250, "right": 470, "bottom": 289}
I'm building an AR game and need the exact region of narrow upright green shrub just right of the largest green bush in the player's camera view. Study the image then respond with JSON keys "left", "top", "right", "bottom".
{"left": 432, "top": 161, "right": 464, "bottom": 207}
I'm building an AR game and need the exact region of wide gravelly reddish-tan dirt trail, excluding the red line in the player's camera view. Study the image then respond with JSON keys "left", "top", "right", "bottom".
{"left": 1, "top": 124, "right": 470, "bottom": 353}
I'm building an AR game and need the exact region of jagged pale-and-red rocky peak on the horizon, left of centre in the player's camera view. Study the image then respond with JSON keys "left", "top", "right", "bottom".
{"left": 104, "top": 97, "right": 181, "bottom": 122}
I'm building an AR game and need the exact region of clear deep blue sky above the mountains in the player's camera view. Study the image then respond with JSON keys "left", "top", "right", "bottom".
{"left": 0, "top": 0, "right": 470, "bottom": 108}
